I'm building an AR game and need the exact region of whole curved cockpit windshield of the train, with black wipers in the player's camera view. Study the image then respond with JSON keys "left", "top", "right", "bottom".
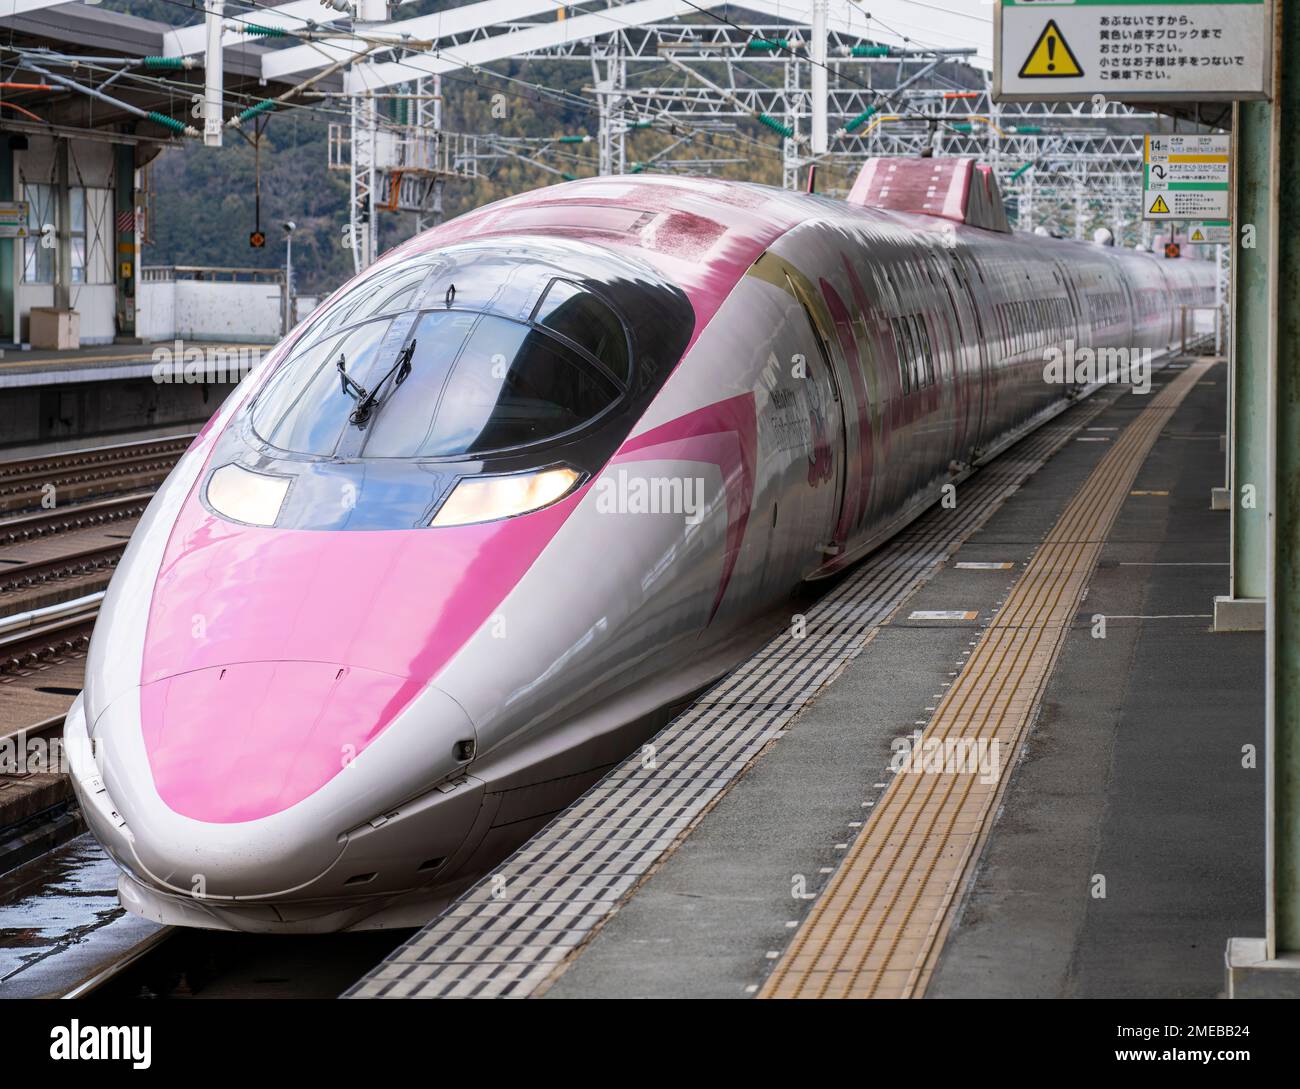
{"left": 252, "top": 305, "right": 629, "bottom": 457}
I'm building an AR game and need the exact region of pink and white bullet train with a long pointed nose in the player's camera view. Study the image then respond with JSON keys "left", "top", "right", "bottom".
{"left": 65, "top": 160, "right": 1214, "bottom": 932}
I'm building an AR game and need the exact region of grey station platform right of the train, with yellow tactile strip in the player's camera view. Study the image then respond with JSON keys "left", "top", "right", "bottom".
{"left": 346, "top": 357, "right": 1265, "bottom": 998}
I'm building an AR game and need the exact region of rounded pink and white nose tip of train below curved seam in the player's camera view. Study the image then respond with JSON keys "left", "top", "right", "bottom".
{"left": 94, "top": 661, "right": 473, "bottom": 898}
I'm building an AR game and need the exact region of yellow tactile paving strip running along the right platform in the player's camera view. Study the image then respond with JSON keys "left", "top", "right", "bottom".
{"left": 759, "top": 361, "right": 1212, "bottom": 998}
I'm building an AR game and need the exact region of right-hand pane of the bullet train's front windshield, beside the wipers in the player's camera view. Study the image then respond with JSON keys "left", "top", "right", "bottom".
{"left": 363, "top": 311, "right": 620, "bottom": 457}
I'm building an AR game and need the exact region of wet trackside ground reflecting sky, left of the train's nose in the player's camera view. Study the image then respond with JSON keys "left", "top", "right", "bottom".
{"left": 0, "top": 834, "right": 157, "bottom": 998}
